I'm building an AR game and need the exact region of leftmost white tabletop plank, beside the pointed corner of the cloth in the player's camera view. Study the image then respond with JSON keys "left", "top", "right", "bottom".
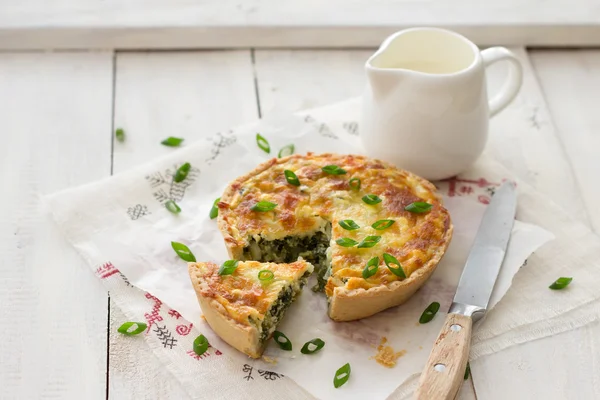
{"left": 0, "top": 52, "right": 113, "bottom": 399}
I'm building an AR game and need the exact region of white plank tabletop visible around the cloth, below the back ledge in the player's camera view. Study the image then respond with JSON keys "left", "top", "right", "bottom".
{"left": 0, "top": 43, "right": 600, "bottom": 400}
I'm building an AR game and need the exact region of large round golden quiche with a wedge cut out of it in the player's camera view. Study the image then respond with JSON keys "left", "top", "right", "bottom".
{"left": 218, "top": 153, "right": 453, "bottom": 321}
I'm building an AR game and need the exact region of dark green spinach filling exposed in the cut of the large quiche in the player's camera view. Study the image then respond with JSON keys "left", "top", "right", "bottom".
{"left": 244, "top": 227, "right": 331, "bottom": 291}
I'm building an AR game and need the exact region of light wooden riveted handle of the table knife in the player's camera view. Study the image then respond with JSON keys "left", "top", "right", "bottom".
{"left": 415, "top": 314, "right": 473, "bottom": 400}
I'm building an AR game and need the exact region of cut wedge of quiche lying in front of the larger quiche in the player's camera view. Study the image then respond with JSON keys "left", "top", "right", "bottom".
{"left": 188, "top": 260, "right": 313, "bottom": 358}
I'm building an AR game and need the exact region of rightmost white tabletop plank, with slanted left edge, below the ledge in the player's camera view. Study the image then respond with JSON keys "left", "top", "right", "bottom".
{"left": 531, "top": 50, "right": 600, "bottom": 232}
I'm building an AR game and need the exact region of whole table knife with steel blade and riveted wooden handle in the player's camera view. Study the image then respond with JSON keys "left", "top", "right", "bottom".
{"left": 415, "top": 182, "right": 517, "bottom": 400}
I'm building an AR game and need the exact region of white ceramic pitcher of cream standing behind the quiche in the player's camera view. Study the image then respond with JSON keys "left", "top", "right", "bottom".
{"left": 360, "top": 28, "right": 522, "bottom": 180}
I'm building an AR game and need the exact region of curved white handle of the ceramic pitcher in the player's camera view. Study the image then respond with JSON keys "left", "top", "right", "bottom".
{"left": 481, "top": 47, "right": 523, "bottom": 117}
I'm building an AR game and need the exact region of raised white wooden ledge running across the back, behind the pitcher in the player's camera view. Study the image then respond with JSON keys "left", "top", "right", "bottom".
{"left": 0, "top": 0, "right": 600, "bottom": 49}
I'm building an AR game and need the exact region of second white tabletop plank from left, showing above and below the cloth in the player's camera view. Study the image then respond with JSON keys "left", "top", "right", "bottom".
{"left": 109, "top": 50, "right": 258, "bottom": 400}
